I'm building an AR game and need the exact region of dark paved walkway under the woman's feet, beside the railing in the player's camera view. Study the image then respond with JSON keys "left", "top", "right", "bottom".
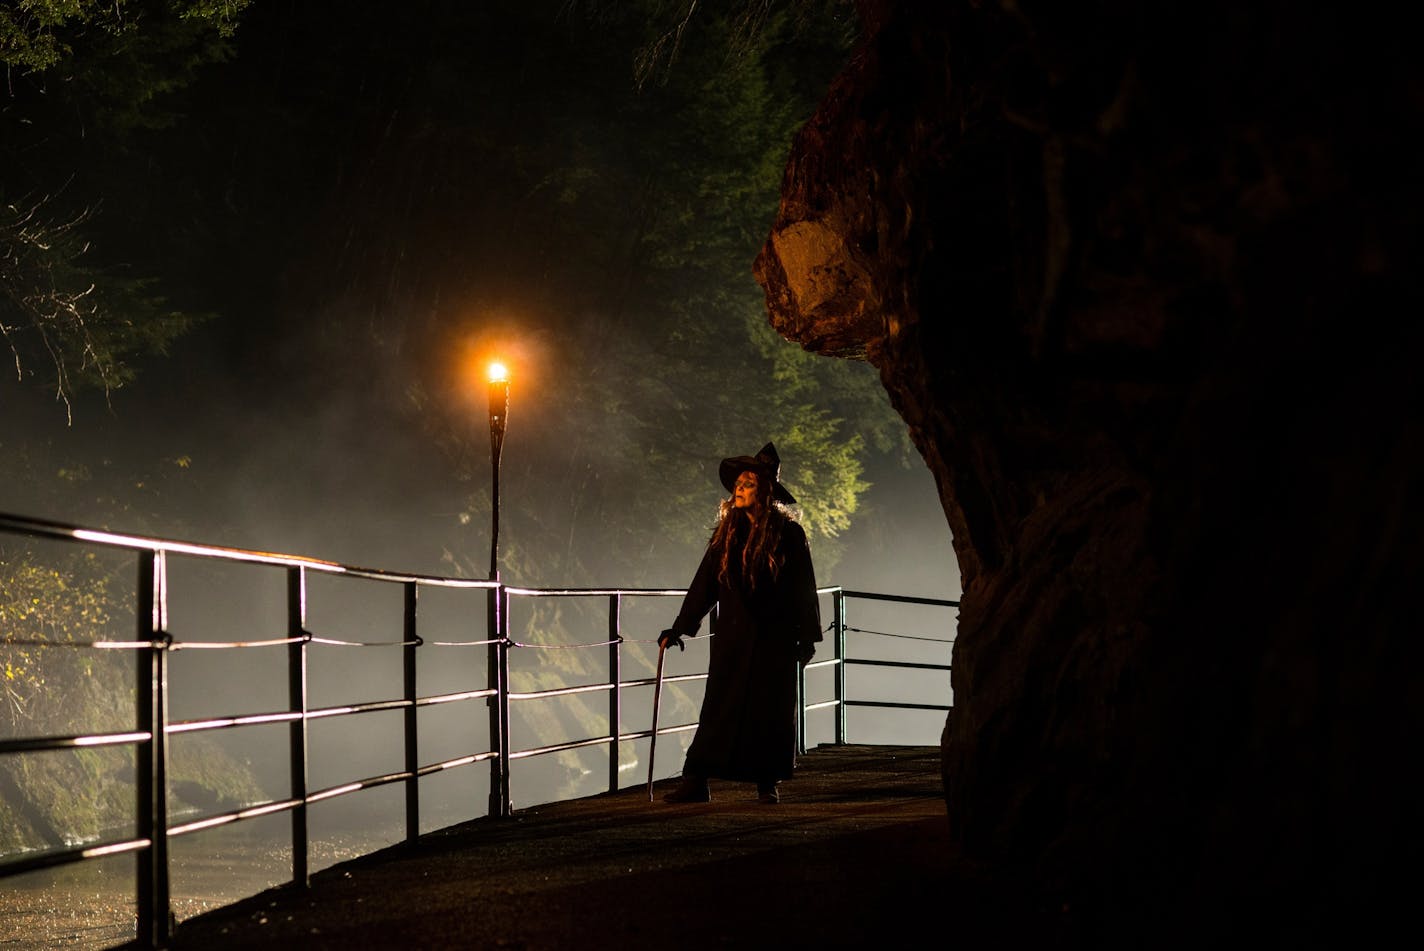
{"left": 153, "top": 746, "right": 1070, "bottom": 951}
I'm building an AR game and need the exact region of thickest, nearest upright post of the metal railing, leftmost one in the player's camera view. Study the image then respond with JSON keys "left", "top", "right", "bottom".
{"left": 134, "top": 551, "right": 172, "bottom": 948}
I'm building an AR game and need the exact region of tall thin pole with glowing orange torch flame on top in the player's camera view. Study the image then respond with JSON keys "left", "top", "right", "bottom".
{"left": 487, "top": 363, "right": 511, "bottom": 816}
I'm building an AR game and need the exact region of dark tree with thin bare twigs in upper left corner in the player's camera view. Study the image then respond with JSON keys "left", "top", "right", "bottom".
{"left": 0, "top": 0, "right": 249, "bottom": 411}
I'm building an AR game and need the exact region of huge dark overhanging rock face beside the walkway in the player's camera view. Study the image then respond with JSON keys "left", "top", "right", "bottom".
{"left": 756, "top": 0, "right": 1424, "bottom": 938}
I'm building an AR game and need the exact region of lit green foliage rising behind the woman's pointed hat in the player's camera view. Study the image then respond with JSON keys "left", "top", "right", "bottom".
{"left": 549, "top": 0, "right": 887, "bottom": 580}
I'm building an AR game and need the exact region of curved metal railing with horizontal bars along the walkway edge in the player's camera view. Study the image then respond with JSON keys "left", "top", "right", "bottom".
{"left": 0, "top": 514, "right": 958, "bottom": 947}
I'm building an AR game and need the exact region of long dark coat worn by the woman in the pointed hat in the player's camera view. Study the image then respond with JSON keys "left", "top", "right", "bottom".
{"left": 672, "top": 513, "right": 820, "bottom": 783}
